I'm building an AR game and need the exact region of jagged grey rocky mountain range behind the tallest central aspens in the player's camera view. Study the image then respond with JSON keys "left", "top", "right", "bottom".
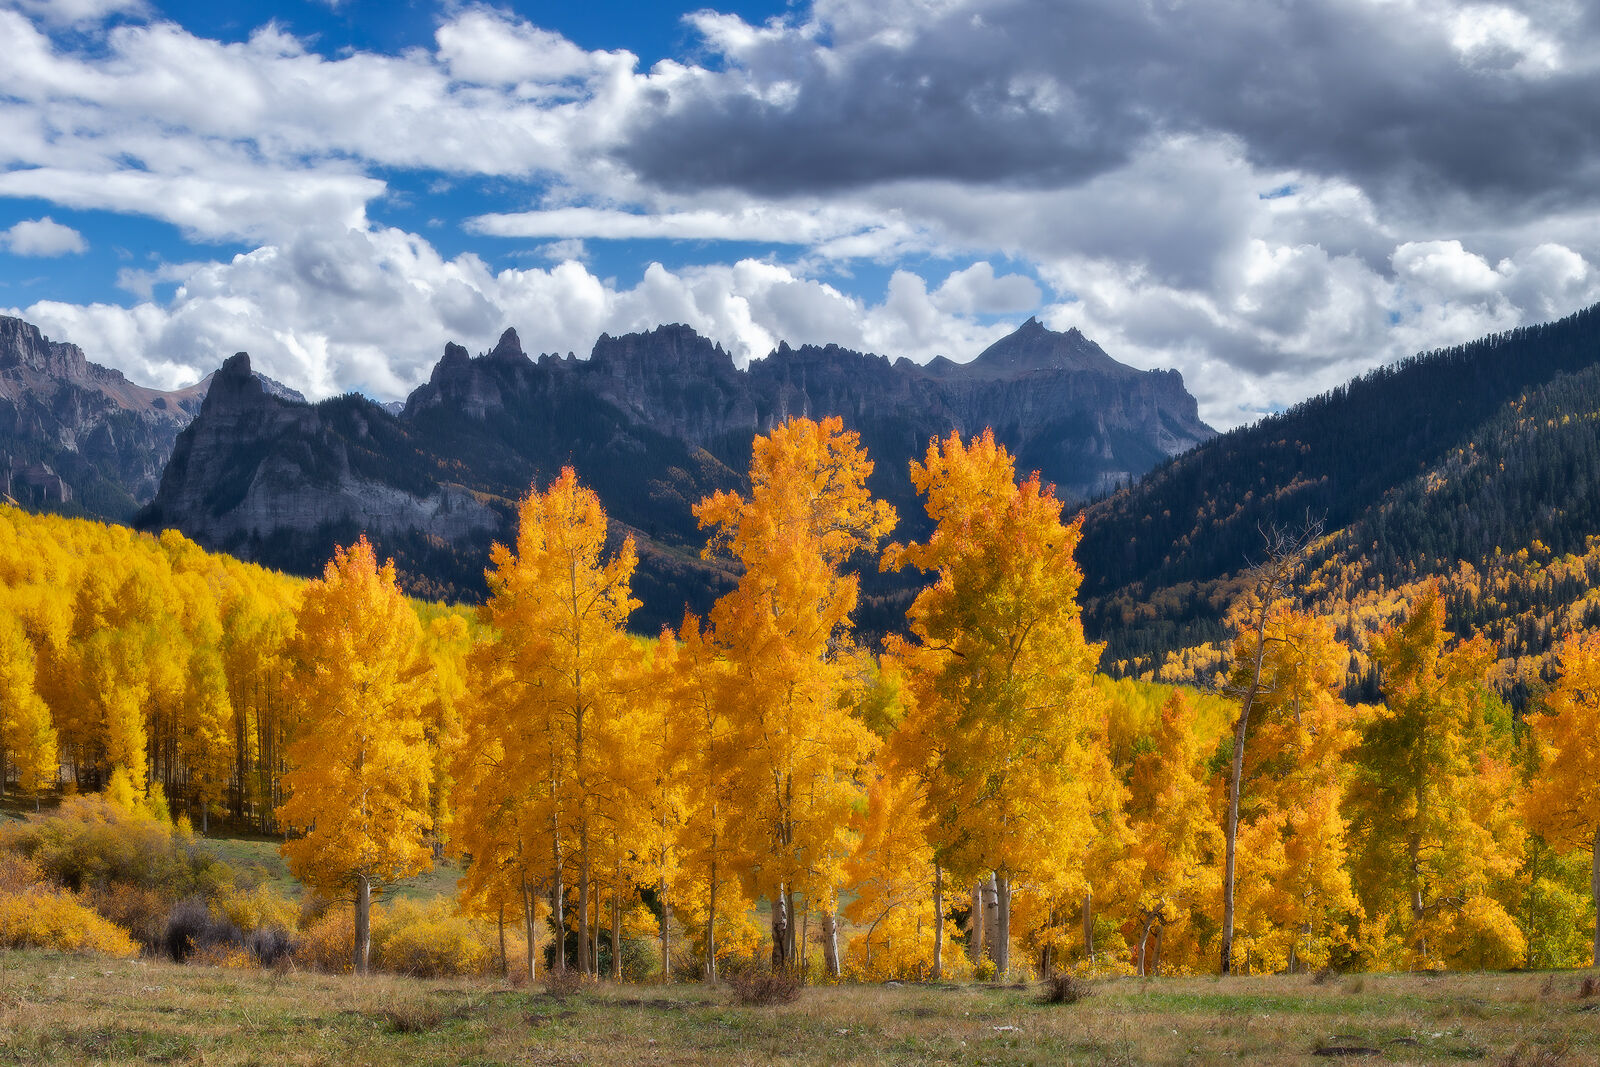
{"left": 139, "top": 320, "right": 1213, "bottom": 630}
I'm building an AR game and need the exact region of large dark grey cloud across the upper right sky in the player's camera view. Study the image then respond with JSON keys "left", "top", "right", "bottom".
{"left": 616, "top": 0, "right": 1600, "bottom": 216}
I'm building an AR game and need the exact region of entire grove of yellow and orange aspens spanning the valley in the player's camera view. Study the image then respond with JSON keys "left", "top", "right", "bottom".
{"left": 0, "top": 418, "right": 1600, "bottom": 981}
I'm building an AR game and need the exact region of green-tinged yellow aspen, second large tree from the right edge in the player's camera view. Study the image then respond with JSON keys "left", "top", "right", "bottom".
{"left": 1346, "top": 587, "right": 1526, "bottom": 966}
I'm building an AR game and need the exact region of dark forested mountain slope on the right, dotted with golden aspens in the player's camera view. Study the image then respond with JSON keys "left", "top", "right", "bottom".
{"left": 1078, "top": 307, "right": 1600, "bottom": 693}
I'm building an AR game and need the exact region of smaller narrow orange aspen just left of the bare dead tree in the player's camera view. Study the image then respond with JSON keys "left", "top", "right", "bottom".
{"left": 1128, "top": 691, "right": 1222, "bottom": 974}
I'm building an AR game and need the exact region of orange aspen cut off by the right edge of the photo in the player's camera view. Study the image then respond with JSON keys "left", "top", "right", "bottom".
{"left": 1523, "top": 632, "right": 1600, "bottom": 966}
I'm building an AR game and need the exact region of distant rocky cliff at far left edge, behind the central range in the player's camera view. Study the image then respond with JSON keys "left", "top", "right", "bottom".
{"left": 0, "top": 317, "right": 299, "bottom": 522}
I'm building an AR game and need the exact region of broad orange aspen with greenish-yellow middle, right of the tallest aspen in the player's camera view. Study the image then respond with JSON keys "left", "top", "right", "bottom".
{"left": 883, "top": 432, "right": 1101, "bottom": 973}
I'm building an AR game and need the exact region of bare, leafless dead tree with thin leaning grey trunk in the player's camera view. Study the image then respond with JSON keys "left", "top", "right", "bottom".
{"left": 1222, "top": 515, "right": 1322, "bottom": 974}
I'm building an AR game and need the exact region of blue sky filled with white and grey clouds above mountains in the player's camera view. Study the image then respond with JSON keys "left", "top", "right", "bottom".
{"left": 0, "top": 0, "right": 1600, "bottom": 429}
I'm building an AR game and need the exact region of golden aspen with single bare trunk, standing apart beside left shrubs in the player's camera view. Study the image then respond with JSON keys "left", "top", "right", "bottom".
{"left": 278, "top": 537, "right": 430, "bottom": 974}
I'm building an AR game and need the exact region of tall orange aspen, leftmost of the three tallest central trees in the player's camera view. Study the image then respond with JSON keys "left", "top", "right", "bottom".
{"left": 458, "top": 467, "right": 642, "bottom": 974}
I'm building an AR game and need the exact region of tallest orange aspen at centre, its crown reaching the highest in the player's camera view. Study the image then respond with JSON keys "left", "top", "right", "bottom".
{"left": 694, "top": 418, "right": 894, "bottom": 974}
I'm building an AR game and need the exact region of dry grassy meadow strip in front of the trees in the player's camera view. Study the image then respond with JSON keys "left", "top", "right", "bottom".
{"left": 0, "top": 952, "right": 1600, "bottom": 1067}
